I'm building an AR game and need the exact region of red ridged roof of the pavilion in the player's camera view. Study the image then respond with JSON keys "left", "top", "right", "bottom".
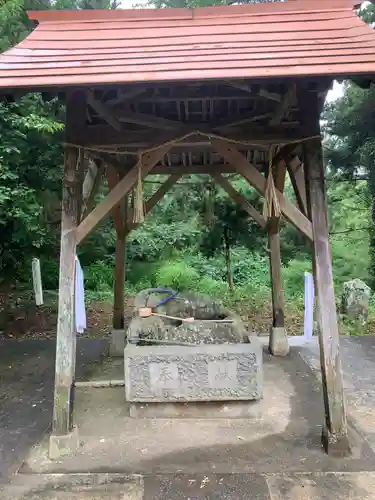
{"left": 0, "top": 0, "right": 375, "bottom": 88}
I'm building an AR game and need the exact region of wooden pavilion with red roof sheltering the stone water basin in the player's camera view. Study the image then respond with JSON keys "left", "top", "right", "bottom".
{"left": 0, "top": 0, "right": 375, "bottom": 456}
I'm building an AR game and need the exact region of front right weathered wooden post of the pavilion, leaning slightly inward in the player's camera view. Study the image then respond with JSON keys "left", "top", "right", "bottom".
{"left": 299, "top": 89, "right": 350, "bottom": 456}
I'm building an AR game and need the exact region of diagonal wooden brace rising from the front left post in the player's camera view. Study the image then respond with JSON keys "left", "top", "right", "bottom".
{"left": 77, "top": 144, "right": 171, "bottom": 243}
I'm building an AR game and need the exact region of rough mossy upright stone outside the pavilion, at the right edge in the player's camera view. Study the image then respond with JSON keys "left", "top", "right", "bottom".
{"left": 341, "top": 279, "right": 371, "bottom": 323}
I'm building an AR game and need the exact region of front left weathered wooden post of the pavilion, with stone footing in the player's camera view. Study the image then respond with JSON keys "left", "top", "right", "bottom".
{"left": 49, "top": 91, "right": 86, "bottom": 459}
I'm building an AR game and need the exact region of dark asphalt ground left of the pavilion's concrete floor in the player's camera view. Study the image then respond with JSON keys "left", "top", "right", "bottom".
{"left": 0, "top": 339, "right": 106, "bottom": 483}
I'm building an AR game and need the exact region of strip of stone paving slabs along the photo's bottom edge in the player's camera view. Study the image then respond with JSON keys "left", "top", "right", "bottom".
{"left": 5, "top": 473, "right": 375, "bottom": 500}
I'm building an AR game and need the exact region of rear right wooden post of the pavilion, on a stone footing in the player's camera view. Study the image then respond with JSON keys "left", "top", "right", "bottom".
{"left": 267, "top": 160, "right": 289, "bottom": 356}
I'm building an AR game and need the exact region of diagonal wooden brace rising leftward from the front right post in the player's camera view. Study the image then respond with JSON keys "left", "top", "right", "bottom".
{"left": 212, "top": 139, "right": 313, "bottom": 240}
